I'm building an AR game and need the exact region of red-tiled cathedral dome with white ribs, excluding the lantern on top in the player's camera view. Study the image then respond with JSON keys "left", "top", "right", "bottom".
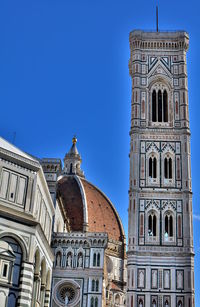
{"left": 57, "top": 174, "right": 124, "bottom": 242}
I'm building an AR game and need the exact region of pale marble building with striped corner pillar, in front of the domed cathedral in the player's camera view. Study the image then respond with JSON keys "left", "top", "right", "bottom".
{"left": 0, "top": 138, "right": 55, "bottom": 307}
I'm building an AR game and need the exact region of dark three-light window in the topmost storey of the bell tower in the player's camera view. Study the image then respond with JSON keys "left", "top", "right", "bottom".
{"left": 152, "top": 90, "right": 168, "bottom": 122}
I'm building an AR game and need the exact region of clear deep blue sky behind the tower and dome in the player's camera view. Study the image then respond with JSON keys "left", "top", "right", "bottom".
{"left": 0, "top": 0, "right": 200, "bottom": 307}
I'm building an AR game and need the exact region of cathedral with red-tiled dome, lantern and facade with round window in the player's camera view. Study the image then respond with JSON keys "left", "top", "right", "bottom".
{"left": 41, "top": 138, "right": 126, "bottom": 307}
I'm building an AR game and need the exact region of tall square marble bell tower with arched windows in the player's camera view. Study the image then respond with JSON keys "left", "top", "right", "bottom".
{"left": 127, "top": 31, "right": 194, "bottom": 307}
